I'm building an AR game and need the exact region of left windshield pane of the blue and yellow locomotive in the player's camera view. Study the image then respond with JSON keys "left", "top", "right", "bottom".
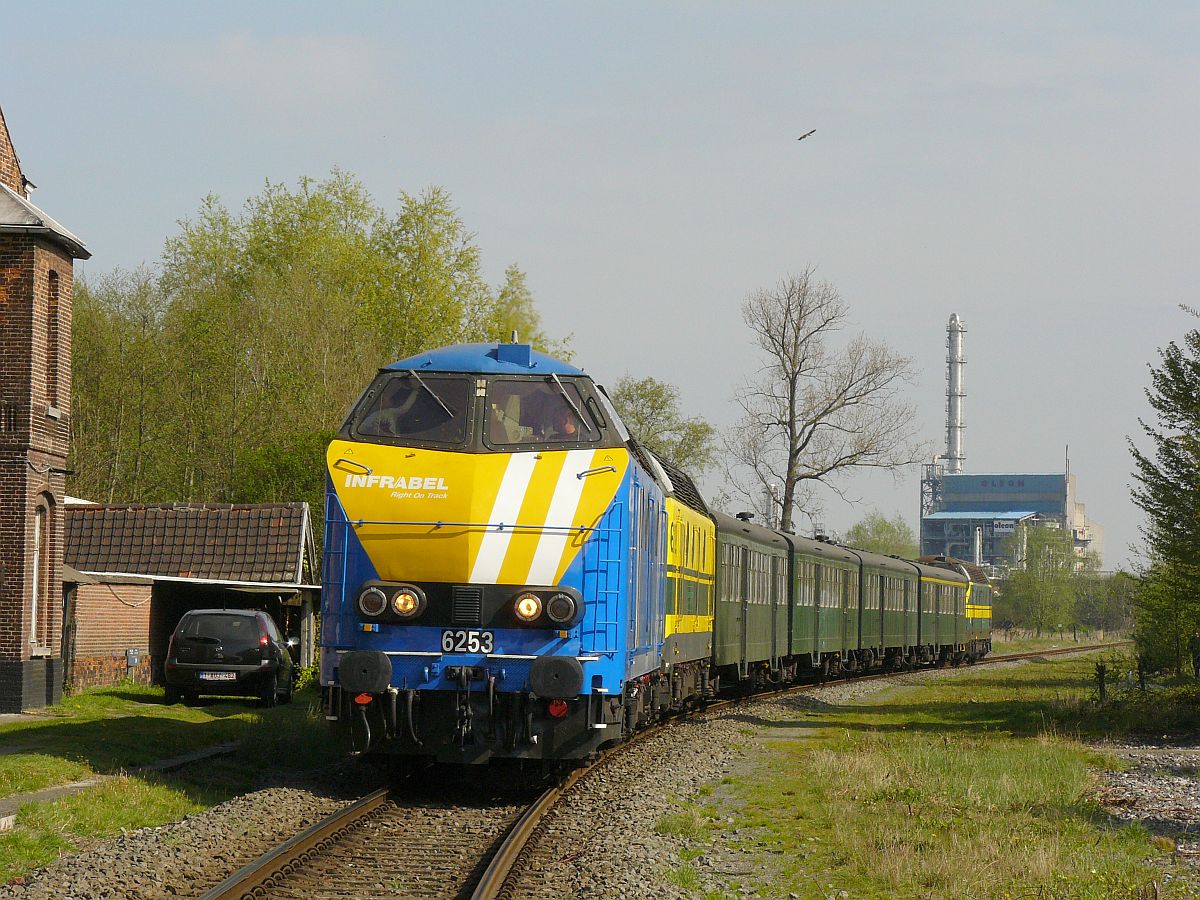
{"left": 355, "top": 370, "right": 470, "bottom": 444}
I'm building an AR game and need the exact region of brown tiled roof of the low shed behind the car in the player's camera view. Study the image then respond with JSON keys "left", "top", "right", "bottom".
{"left": 65, "top": 503, "right": 308, "bottom": 584}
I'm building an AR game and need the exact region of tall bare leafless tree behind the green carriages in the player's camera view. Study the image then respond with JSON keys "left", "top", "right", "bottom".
{"left": 726, "top": 266, "right": 928, "bottom": 530}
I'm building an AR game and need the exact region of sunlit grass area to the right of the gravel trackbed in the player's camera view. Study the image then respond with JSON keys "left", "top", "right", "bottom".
{"left": 668, "top": 658, "right": 1198, "bottom": 900}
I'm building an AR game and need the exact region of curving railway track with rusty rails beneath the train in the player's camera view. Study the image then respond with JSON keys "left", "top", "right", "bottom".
{"left": 202, "top": 641, "right": 1130, "bottom": 900}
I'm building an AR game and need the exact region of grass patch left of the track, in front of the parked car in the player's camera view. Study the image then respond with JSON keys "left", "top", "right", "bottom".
{"left": 0, "top": 684, "right": 346, "bottom": 884}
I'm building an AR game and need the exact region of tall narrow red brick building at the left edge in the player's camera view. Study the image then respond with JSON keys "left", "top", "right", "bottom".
{"left": 0, "top": 103, "right": 91, "bottom": 712}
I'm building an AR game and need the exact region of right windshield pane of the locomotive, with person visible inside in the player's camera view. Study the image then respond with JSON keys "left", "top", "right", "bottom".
{"left": 485, "top": 378, "right": 600, "bottom": 444}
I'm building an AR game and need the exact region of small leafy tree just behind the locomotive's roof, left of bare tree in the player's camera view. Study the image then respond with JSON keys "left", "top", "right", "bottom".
{"left": 608, "top": 376, "right": 718, "bottom": 475}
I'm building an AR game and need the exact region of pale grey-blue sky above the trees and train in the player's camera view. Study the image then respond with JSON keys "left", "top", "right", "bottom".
{"left": 0, "top": 0, "right": 1200, "bottom": 568}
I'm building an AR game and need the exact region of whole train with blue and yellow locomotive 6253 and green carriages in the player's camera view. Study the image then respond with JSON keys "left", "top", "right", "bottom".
{"left": 320, "top": 342, "right": 991, "bottom": 764}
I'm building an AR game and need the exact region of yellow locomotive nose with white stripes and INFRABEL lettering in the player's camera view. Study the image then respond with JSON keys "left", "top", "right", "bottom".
{"left": 328, "top": 440, "right": 629, "bottom": 584}
